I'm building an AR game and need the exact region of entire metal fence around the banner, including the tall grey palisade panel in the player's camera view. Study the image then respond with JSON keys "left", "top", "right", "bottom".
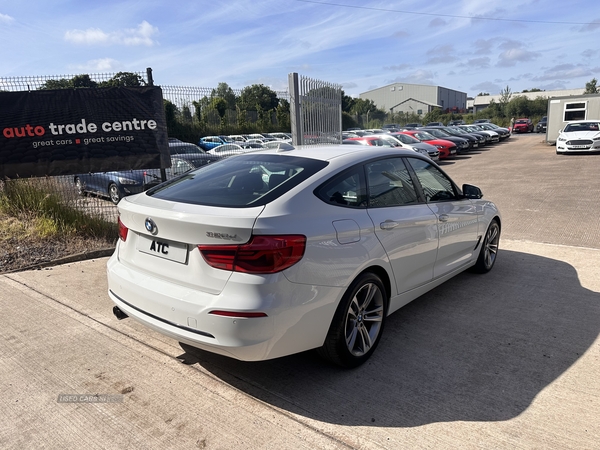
{"left": 0, "top": 69, "right": 342, "bottom": 227}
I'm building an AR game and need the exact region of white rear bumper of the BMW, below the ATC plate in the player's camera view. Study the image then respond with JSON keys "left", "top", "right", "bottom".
{"left": 107, "top": 254, "right": 343, "bottom": 361}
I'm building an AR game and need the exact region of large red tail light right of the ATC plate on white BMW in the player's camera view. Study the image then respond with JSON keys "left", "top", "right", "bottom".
{"left": 198, "top": 235, "right": 306, "bottom": 274}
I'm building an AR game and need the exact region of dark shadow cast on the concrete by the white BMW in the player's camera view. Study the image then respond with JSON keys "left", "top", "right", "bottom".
{"left": 179, "top": 251, "right": 600, "bottom": 427}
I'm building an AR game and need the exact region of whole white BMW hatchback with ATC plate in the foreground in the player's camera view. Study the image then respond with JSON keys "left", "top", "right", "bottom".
{"left": 107, "top": 145, "right": 501, "bottom": 367}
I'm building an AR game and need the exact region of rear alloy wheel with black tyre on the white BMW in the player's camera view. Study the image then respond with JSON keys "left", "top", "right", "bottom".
{"left": 318, "top": 273, "right": 388, "bottom": 368}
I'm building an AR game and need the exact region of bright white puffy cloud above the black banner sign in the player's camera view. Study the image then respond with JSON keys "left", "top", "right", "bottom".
{"left": 65, "top": 20, "right": 158, "bottom": 46}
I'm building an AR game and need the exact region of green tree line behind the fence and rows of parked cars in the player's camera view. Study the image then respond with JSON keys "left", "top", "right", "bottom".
{"left": 35, "top": 72, "right": 600, "bottom": 137}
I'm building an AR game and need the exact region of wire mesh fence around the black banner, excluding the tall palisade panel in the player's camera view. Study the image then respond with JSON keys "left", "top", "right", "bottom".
{"left": 0, "top": 69, "right": 289, "bottom": 222}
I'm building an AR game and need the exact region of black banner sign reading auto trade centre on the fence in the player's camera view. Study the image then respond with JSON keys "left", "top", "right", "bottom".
{"left": 0, "top": 87, "right": 171, "bottom": 178}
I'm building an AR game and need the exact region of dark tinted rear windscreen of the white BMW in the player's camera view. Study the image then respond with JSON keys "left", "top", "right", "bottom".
{"left": 146, "top": 154, "right": 327, "bottom": 208}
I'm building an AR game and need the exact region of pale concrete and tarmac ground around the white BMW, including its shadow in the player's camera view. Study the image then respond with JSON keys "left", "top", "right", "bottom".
{"left": 0, "top": 134, "right": 600, "bottom": 449}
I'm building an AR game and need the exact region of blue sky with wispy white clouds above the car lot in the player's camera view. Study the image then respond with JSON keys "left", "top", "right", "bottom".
{"left": 0, "top": 0, "right": 600, "bottom": 97}
